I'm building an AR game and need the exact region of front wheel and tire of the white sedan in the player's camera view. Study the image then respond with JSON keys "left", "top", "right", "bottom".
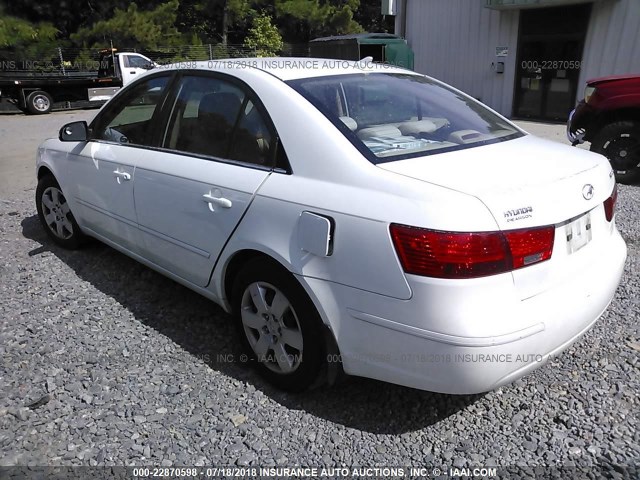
{"left": 36, "top": 175, "right": 86, "bottom": 250}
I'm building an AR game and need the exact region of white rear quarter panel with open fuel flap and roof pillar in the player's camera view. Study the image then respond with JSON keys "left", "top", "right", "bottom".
{"left": 212, "top": 69, "right": 504, "bottom": 308}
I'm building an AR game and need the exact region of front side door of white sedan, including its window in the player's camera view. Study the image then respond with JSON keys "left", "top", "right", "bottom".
{"left": 68, "top": 74, "right": 169, "bottom": 251}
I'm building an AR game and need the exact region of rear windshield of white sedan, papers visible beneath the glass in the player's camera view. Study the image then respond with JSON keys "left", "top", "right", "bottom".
{"left": 287, "top": 73, "right": 523, "bottom": 163}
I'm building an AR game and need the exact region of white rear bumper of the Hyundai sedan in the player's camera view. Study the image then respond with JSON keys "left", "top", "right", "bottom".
{"left": 305, "top": 225, "right": 626, "bottom": 394}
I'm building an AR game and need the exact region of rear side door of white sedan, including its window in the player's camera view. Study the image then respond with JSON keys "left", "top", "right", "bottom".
{"left": 135, "top": 73, "right": 275, "bottom": 286}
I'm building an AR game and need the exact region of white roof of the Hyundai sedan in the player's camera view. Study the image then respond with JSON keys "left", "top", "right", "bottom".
{"left": 160, "top": 57, "right": 418, "bottom": 81}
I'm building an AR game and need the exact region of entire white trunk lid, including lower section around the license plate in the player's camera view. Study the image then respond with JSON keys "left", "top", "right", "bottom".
{"left": 379, "top": 135, "right": 615, "bottom": 299}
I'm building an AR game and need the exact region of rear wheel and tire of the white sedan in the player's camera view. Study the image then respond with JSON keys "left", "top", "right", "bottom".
{"left": 232, "top": 258, "right": 326, "bottom": 392}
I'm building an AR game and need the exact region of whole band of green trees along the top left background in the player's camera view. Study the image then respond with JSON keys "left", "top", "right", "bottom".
{"left": 0, "top": 0, "right": 384, "bottom": 59}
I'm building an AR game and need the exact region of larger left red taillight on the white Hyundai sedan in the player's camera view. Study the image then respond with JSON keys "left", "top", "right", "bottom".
{"left": 390, "top": 223, "right": 555, "bottom": 278}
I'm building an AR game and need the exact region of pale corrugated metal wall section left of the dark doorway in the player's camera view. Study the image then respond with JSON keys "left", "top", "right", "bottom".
{"left": 398, "top": 0, "right": 520, "bottom": 116}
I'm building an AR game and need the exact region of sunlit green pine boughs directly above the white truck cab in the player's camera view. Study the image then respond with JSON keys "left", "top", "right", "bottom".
{"left": 71, "top": 0, "right": 182, "bottom": 49}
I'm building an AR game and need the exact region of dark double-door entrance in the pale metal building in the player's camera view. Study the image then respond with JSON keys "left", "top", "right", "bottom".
{"left": 514, "top": 4, "right": 591, "bottom": 122}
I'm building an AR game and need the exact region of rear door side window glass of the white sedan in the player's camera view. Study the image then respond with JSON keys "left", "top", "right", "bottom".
{"left": 164, "top": 76, "right": 273, "bottom": 166}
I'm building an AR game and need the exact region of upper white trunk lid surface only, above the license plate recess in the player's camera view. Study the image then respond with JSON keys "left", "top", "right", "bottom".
{"left": 379, "top": 135, "right": 614, "bottom": 230}
